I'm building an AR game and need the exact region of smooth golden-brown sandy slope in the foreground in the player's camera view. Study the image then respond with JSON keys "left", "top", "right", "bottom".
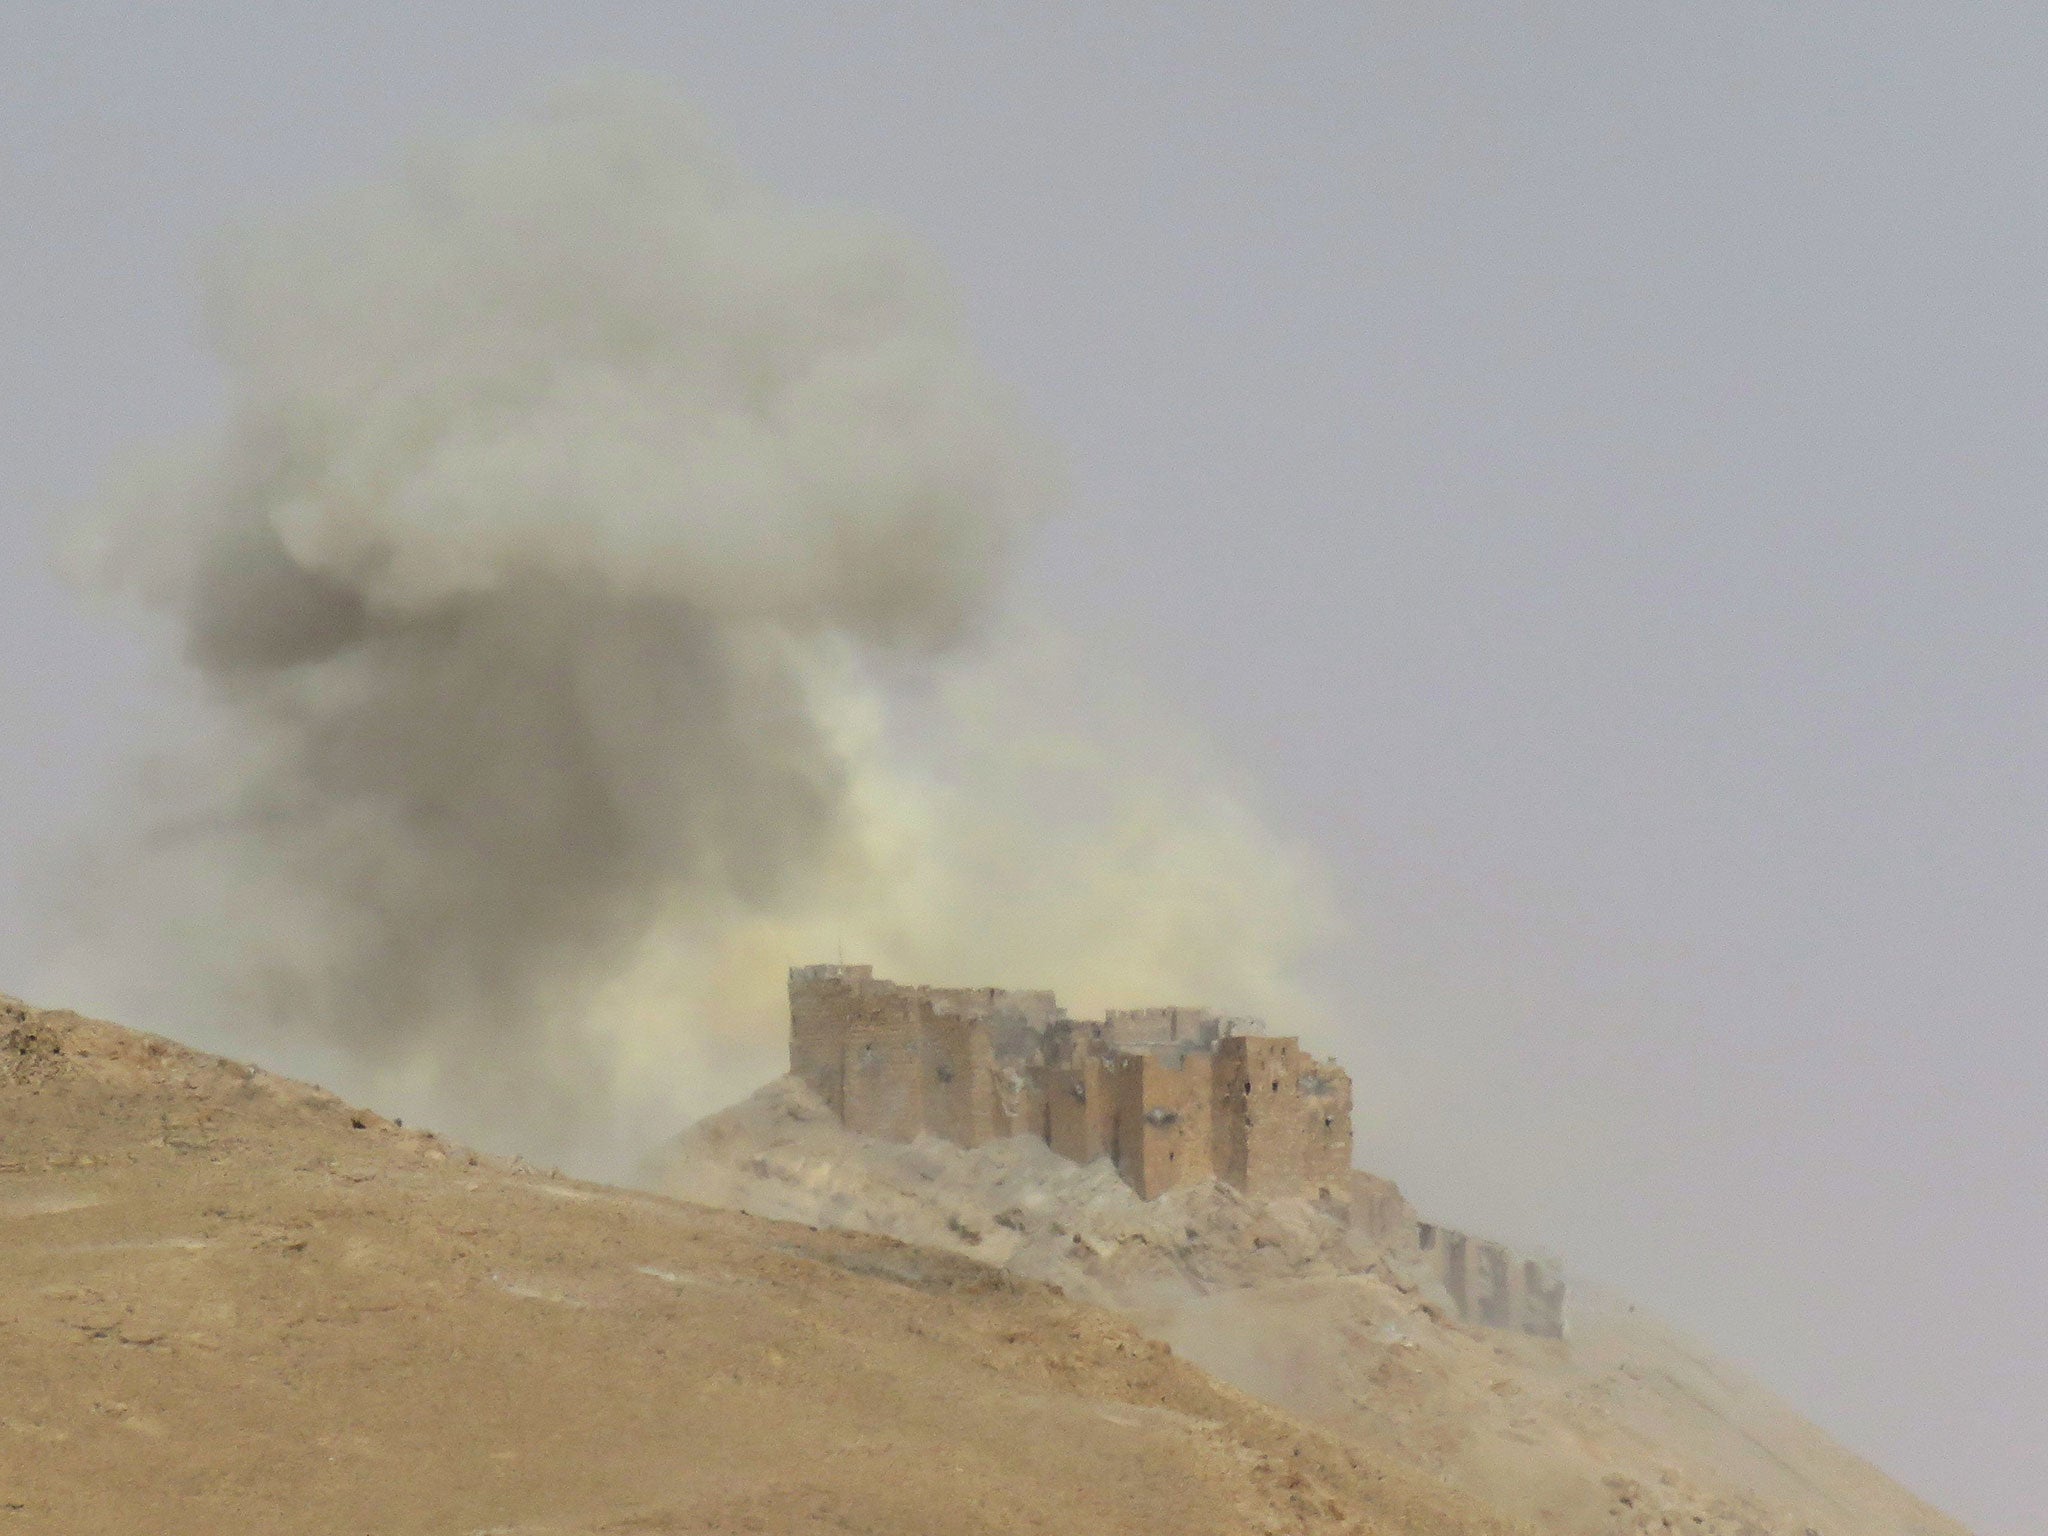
{"left": 0, "top": 1001, "right": 1507, "bottom": 1536}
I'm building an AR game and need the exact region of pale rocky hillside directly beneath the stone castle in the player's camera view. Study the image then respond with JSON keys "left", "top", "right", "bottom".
{"left": 649, "top": 1079, "right": 1968, "bottom": 1536}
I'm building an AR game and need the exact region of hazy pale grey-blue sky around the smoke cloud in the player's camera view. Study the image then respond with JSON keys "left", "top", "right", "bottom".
{"left": 0, "top": 0, "right": 2048, "bottom": 1536}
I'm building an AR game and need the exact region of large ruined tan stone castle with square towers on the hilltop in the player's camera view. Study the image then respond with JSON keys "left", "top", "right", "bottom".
{"left": 788, "top": 965, "right": 1352, "bottom": 1206}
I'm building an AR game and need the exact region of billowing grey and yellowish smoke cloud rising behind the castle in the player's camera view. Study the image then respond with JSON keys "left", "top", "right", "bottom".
{"left": 48, "top": 84, "right": 1315, "bottom": 1155}
